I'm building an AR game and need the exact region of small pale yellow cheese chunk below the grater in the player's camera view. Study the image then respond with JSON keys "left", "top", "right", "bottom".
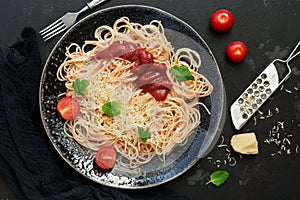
{"left": 230, "top": 132, "right": 258, "bottom": 154}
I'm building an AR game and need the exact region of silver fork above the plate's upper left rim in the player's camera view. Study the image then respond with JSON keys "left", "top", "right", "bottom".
{"left": 39, "top": 0, "right": 107, "bottom": 41}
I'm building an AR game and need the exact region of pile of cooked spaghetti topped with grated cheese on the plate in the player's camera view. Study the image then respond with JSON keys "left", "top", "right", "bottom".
{"left": 57, "top": 17, "right": 213, "bottom": 168}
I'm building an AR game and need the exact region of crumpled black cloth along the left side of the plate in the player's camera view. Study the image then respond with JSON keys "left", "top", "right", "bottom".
{"left": 0, "top": 28, "right": 188, "bottom": 200}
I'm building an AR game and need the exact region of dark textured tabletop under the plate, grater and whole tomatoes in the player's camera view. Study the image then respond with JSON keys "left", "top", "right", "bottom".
{"left": 0, "top": 0, "right": 300, "bottom": 200}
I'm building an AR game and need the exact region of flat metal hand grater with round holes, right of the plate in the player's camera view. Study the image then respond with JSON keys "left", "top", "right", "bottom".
{"left": 230, "top": 41, "right": 300, "bottom": 130}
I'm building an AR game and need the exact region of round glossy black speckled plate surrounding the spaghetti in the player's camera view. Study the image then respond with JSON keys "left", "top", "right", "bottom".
{"left": 40, "top": 5, "right": 226, "bottom": 188}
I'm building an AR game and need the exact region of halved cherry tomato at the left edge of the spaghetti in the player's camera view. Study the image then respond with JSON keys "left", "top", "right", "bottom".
{"left": 56, "top": 97, "right": 80, "bottom": 120}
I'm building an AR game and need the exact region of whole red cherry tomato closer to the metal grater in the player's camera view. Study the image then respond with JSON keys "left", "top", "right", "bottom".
{"left": 226, "top": 41, "right": 248, "bottom": 62}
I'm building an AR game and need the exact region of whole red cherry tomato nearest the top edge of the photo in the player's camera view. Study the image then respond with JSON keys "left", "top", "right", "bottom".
{"left": 210, "top": 9, "right": 234, "bottom": 32}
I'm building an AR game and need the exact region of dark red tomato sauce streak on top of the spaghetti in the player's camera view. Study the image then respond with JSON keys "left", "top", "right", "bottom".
{"left": 95, "top": 42, "right": 173, "bottom": 101}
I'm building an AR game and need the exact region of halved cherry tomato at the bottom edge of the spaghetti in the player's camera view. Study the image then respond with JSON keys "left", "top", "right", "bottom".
{"left": 95, "top": 146, "right": 117, "bottom": 170}
